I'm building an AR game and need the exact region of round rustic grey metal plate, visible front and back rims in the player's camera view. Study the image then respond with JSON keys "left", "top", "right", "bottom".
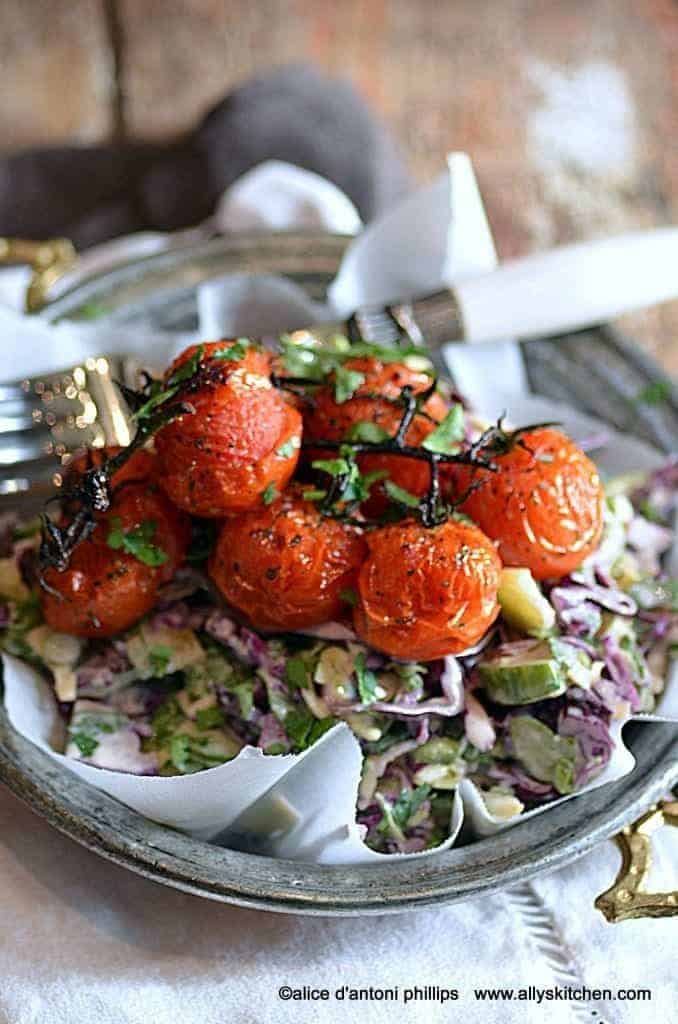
{"left": 0, "top": 234, "right": 678, "bottom": 914}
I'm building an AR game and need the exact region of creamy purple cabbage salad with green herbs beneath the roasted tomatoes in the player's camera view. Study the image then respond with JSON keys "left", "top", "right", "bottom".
{"left": 0, "top": 461, "right": 678, "bottom": 853}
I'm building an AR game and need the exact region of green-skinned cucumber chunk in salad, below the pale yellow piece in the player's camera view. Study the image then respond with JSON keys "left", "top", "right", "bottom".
{"left": 478, "top": 641, "right": 567, "bottom": 705}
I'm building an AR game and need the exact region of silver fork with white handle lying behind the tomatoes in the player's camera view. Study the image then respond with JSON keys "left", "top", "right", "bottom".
{"left": 5, "top": 228, "right": 678, "bottom": 505}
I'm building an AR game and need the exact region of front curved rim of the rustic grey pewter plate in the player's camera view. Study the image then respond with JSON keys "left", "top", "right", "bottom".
{"left": 0, "top": 711, "right": 678, "bottom": 916}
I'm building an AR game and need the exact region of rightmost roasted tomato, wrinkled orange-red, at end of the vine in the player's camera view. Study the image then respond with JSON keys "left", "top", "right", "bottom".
{"left": 452, "top": 427, "right": 603, "bottom": 580}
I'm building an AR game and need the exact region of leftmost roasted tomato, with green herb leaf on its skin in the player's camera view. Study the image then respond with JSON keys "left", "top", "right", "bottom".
{"left": 42, "top": 481, "right": 190, "bottom": 637}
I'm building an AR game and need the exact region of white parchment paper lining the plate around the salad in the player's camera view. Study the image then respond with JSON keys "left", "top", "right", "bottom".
{"left": 0, "top": 155, "right": 678, "bottom": 863}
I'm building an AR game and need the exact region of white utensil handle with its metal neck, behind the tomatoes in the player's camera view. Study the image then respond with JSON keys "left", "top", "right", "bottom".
{"left": 327, "top": 227, "right": 678, "bottom": 350}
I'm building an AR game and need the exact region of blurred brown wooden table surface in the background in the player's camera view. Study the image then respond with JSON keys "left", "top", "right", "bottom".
{"left": 0, "top": 0, "right": 678, "bottom": 372}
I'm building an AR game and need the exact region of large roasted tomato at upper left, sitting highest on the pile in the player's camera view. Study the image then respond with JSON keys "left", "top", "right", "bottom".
{"left": 156, "top": 341, "right": 301, "bottom": 518}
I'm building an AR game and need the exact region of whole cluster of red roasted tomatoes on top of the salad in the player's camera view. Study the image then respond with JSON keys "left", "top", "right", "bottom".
{"left": 43, "top": 341, "right": 602, "bottom": 660}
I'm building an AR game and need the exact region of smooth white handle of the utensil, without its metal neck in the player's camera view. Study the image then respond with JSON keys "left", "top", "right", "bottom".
{"left": 453, "top": 227, "right": 678, "bottom": 342}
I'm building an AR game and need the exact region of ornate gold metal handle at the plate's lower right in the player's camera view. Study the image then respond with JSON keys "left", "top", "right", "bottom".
{"left": 595, "top": 800, "right": 678, "bottom": 924}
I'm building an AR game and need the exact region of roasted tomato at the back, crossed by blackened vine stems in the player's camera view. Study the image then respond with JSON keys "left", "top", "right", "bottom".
{"left": 304, "top": 357, "right": 448, "bottom": 515}
